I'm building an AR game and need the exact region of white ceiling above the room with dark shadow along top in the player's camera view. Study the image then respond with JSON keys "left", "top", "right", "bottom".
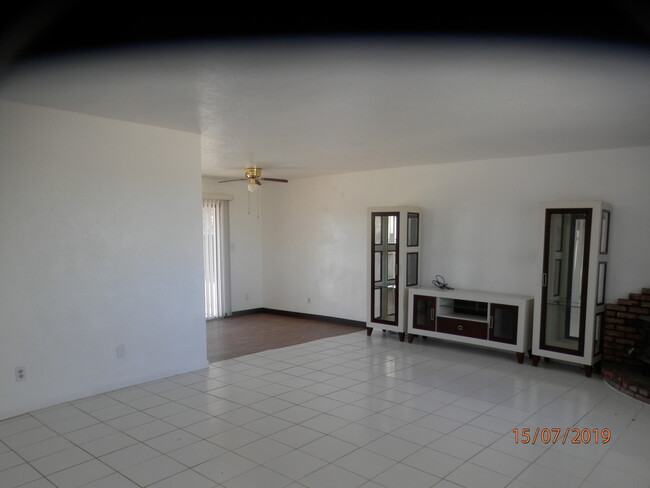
{"left": 0, "top": 36, "right": 650, "bottom": 179}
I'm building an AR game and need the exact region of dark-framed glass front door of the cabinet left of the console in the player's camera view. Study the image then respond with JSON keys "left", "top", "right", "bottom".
{"left": 370, "top": 212, "right": 399, "bottom": 325}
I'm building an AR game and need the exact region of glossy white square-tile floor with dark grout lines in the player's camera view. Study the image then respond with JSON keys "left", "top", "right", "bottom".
{"left": 0, "top": 331, "right": 650, "bottom": 488}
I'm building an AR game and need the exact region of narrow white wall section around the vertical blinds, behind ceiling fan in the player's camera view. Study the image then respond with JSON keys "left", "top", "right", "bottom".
{"left": 202, "top": 177, "right": 264, "bottom": 312}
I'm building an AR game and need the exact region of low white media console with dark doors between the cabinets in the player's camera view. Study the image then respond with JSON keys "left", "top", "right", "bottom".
{"left": 407, "top": 286, "right": 533, "bottom": 363}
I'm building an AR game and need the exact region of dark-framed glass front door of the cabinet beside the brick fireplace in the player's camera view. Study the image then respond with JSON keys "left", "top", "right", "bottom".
{"left": 541, "top": 209, "right": 591, "bottom": 354}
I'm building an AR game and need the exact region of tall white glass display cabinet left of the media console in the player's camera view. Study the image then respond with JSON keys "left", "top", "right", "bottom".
{"left": 366, "top": 207, "right": 420, "bottom": 341}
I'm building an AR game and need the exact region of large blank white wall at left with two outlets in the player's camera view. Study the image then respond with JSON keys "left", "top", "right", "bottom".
{"left": 0, "top": 102, "right": 207, "bottom": 418}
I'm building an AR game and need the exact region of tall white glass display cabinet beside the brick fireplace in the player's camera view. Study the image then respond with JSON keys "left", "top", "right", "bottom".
{"left": 531, "top": 201, "right": 611, "bottom": 376}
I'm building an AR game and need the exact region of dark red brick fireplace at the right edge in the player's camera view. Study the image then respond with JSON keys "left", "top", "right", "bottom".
{"left": 601, "top": 288, "right": 650, "bottom": 403}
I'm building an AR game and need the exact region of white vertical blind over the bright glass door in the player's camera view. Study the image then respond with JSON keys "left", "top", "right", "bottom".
{"left": 203, "top": 200, "right": 232, "bottom": 319}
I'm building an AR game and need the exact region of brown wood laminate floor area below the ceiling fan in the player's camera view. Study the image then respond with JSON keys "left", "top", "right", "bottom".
{"left": 206, "top": 313, "right": 361, "bottom": 363}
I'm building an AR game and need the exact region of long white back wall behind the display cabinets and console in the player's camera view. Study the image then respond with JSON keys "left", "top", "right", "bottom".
{"left": 262, "top": 147, "right": 650, "bottom": 321}
